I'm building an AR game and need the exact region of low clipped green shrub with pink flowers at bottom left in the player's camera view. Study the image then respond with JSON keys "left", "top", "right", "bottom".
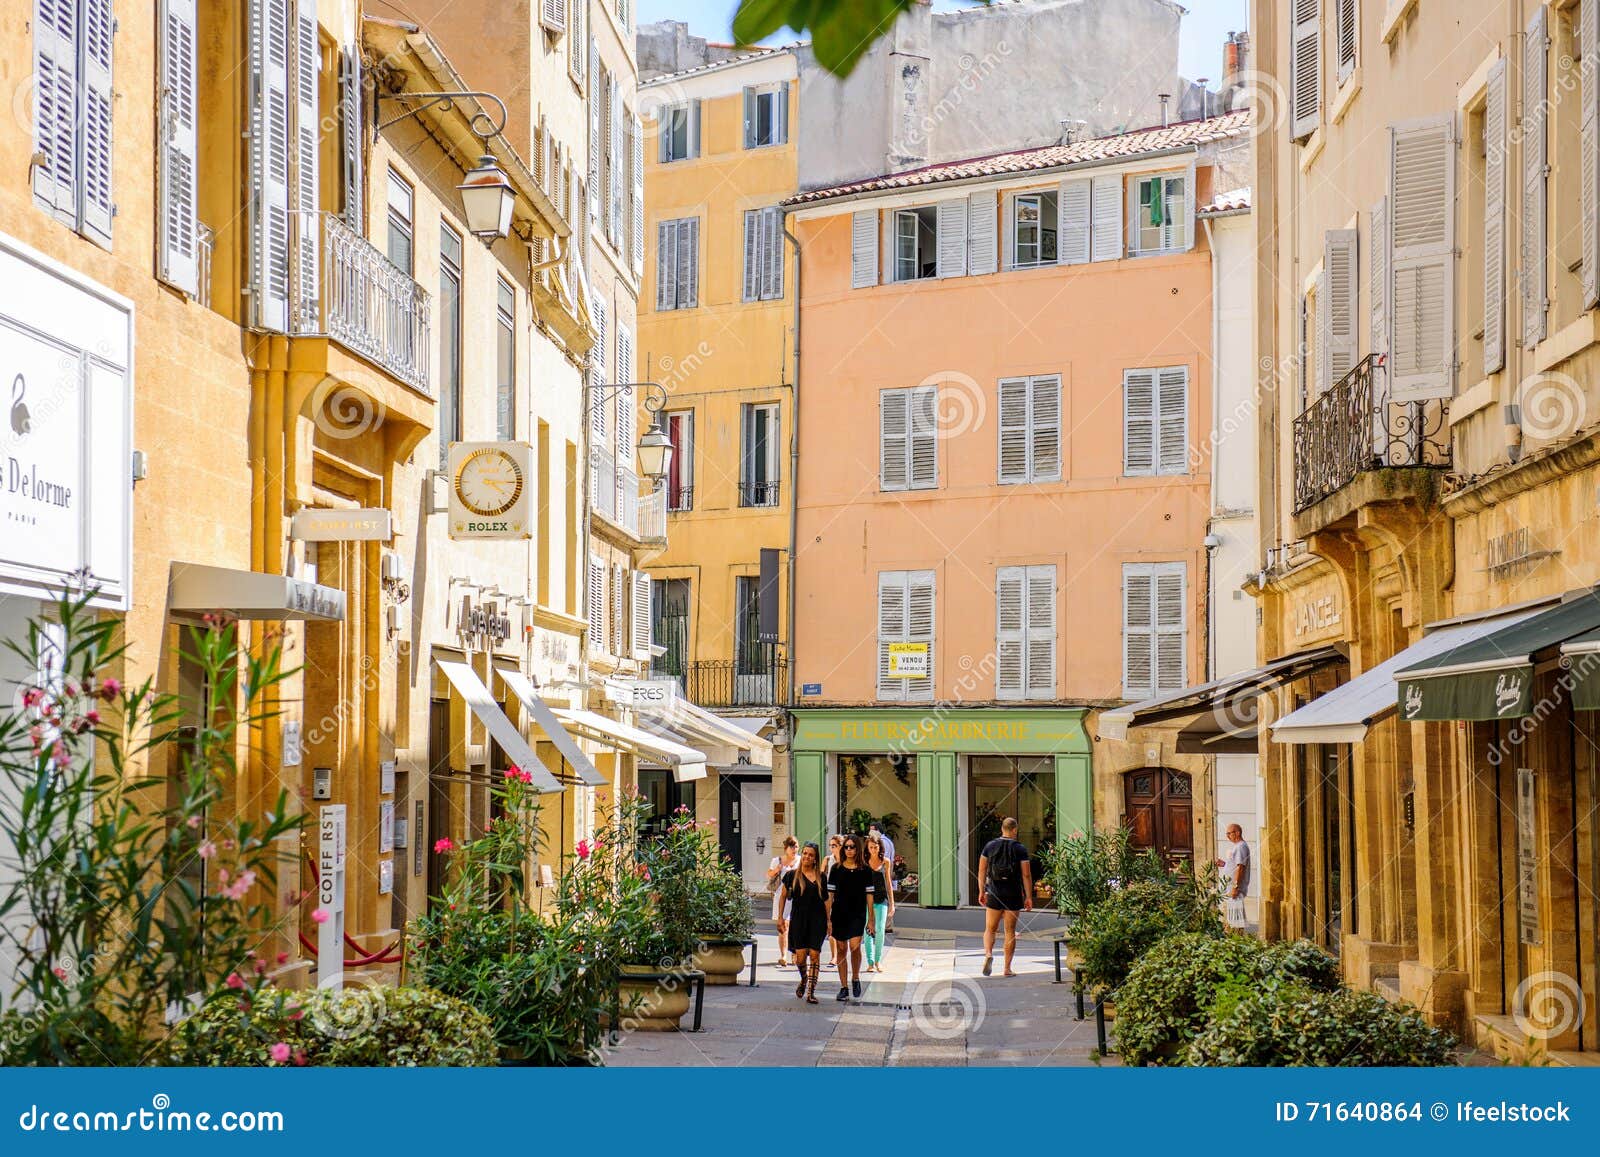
{"left": 165, "top": 986, "right": 499, "bottom": 1069}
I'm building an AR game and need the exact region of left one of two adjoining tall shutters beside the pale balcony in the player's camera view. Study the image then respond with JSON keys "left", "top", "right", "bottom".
{"left": 250, "top": 0, "right": 290, "bottom": 333}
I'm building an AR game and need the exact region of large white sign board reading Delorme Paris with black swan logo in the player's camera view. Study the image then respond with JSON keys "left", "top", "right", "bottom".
{"left": 0, "top": 235, "right": 133, "bottom": 610}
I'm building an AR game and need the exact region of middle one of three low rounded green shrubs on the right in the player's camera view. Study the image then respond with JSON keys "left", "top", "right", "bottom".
{"left": 1117, "top": 933, "right": 1339, "bottom": 1064}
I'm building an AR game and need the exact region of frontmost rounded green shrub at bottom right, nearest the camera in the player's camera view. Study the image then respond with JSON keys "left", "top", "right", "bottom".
{"left": 1184, "top": 984, "right": 1456, "bottom": 1067}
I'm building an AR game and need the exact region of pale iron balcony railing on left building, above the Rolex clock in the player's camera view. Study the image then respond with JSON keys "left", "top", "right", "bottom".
{"left": 290, "top": 210, "right": 434, "bottom": 397}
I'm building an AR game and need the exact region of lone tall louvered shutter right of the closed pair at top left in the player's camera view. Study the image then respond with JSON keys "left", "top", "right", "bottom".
{"left": 157, "top": 0, "right": 200, "bottom": 298}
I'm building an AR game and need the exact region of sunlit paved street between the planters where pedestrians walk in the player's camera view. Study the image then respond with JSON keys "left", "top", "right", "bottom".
{"left": 606, "top": 925, "right": 1117, "bottom": 1066}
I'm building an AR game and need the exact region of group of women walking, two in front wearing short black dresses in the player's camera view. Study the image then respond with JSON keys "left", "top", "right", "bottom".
{"left": 766, "top": 824, "right": 894, "bottom": 1005}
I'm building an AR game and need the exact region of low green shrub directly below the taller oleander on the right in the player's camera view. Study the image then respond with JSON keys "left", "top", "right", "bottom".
{"left": 1067, "top": 874, "right": 1222, "bottom": 989}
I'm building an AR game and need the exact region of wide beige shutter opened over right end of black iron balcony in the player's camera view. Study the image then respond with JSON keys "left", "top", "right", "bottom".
{"left": 1389, "top": 115, "right": 1456, "bottom": 402}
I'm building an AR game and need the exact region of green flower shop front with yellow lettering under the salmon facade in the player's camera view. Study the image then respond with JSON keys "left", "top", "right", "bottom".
{"left": 790, "top": 707, "right": 1093, "bottom": 907}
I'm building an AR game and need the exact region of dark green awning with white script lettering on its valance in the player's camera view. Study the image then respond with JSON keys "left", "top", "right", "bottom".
{"left": 1395, "top": 591, "right": 1600, "bottom": 722}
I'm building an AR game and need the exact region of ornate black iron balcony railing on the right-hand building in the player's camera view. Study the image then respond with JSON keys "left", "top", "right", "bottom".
{"left": 1294, "top": 354, "right": 1450, "bottom": 514}
